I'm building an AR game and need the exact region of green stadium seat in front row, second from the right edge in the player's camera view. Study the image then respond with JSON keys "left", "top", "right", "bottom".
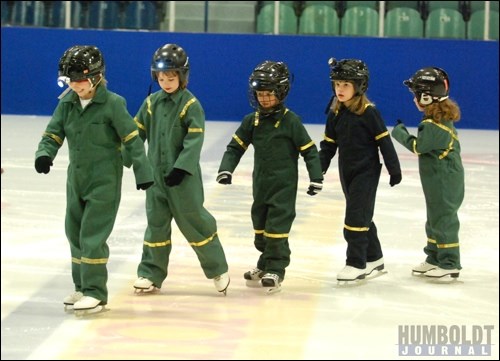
{"left": 425, "top": 9, "right": 465, "bottom": 39}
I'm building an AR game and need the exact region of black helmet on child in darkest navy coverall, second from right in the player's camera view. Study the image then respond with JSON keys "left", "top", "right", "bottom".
{"left": 328, "top": 58, "right": 370, "bottom": 95}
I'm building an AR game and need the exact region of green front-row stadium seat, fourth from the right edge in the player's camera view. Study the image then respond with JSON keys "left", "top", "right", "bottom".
{"left": 340, "top": 6, "right": 378, "bottom": 36}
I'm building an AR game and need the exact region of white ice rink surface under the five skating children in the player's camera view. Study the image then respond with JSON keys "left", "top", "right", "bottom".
{"left": 1, "top": 115, "right": 499, "bottom": 360}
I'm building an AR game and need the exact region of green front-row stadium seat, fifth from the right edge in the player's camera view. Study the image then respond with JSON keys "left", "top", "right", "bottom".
{"left": 299, "top": 4, "right": 340, "bottom": 35}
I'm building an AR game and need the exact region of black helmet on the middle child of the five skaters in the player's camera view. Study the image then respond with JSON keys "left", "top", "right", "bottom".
{"left": 248, "top": 60, "right": 290, "bottom": 113}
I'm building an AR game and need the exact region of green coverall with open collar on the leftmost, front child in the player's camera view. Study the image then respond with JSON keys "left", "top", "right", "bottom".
{"left": 36, "top": 85, "right": 153, "bottom": 304}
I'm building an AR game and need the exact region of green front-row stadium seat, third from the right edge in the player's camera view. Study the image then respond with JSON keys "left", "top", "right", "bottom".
{"left": 384, "top": 8, "right": 424, "bottom": 38}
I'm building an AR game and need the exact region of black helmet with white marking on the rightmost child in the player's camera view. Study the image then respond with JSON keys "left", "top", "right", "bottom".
{"left": 403, "top": 67, "right": 450, "bottom": 105}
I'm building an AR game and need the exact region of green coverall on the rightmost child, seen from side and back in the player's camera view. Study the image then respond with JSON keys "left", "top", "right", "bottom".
{"left": 392, "top": 119, "right": 464, "bottom": 269}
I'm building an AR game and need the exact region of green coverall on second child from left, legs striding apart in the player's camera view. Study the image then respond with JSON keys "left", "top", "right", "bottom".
{"left": 135, "top": 89, "right": 228, "bottom": 288}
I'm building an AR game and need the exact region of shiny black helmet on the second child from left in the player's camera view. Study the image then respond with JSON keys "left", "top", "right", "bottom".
{"left": 151, "top": 44, "right": 189, "bottom": 85}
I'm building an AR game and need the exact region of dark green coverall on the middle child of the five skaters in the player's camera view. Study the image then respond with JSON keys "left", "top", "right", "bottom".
{"left": 219, "top": 107, "right": 323, "bottom": 280}
